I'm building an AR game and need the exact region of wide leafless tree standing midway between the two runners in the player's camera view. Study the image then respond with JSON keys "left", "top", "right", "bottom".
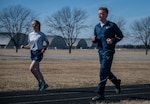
{"left": 46, "top": 7, "right": 87, "bottom": 54}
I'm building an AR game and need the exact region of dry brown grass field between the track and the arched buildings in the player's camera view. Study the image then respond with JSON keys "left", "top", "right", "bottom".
{"left": 0, "top": 49, "right": 150, "bottom": 104}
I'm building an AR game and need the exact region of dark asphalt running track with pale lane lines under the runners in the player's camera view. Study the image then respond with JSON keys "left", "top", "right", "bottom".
{"left": 0, "top": 84, "right": 150, "bottom": 104}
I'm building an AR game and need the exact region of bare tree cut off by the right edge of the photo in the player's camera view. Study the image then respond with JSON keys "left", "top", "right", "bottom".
{"left": 131, "top": 16, "right": 150, "bottom": 55}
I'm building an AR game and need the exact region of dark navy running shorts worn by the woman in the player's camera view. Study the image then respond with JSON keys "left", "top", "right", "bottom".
{"left": 31, "top": 50, "right": 43, "bottom": 62}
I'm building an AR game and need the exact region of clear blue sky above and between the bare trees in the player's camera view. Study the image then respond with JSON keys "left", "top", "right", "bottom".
{"left": 0, "top": 0, "right": 150, "bottom": 44}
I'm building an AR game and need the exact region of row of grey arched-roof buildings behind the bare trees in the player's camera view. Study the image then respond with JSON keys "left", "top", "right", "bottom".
{"left": 0, "top": 33, "right": 96, "bottom": 49}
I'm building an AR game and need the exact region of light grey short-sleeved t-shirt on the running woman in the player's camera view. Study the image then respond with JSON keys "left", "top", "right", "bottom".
{"left": 28, "top": 31, "right": 48, "bottom": 50}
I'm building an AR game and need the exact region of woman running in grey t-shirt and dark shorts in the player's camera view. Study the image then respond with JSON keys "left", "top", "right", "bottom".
{"left": 21, "top": 20, "right": 49, "bottom": 91}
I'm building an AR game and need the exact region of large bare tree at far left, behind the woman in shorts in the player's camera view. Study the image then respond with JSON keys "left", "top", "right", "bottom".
{"left": 0, "top": 5, "right": 36, "bottom": 52}
